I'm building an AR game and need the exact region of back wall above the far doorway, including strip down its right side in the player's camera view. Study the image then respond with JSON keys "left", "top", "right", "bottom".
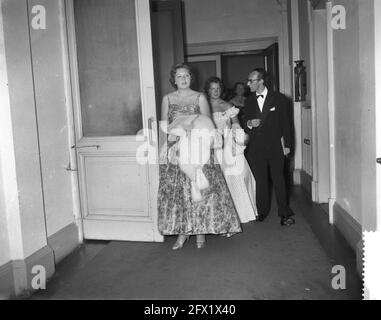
{"left": 184, "top": 0, "right": 292, "bottom": 96}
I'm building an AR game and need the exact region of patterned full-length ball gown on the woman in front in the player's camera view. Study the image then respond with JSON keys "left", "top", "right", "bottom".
{"left": 158, "top": 95, "right": 242, "bottom": 235}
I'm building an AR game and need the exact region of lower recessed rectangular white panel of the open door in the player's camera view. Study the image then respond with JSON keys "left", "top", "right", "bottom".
{"left": 81, "top": 154, "right": 148, "bottom": 219}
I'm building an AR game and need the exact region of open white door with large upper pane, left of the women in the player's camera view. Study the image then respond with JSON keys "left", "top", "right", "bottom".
{"left": 67, "top": 0, "right": 163, "bottom": 241}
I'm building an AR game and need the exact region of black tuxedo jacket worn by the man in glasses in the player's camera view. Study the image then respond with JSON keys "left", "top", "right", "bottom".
{"left": 242, "top": 90, "right": 291, "bottom": 157}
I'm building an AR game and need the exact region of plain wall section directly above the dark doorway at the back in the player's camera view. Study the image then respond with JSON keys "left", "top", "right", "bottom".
{"left": 184, "top": 0, "right": 281, "bottom": 44}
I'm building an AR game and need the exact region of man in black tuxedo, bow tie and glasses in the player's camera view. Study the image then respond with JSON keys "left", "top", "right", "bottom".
{"left": 243, "top": 68, "right": 295, "bottom": 226}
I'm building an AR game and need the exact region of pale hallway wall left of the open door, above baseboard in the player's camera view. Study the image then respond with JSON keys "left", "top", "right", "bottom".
{"left": 3, "top": 0, "right": 74, "bottom": 256}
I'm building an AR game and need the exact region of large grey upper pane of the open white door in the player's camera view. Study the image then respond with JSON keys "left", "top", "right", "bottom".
{"left": 74, "top": 0, "right": 143, "bottom": 137}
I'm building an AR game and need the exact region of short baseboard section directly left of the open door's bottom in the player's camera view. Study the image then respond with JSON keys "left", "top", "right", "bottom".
{"left": 48, "top": 223, "right": 79, "bottom": 264}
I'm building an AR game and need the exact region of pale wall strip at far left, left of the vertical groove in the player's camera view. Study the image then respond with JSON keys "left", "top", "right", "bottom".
{"left": 2, "top": 1, "right": 46, "bottom": 259}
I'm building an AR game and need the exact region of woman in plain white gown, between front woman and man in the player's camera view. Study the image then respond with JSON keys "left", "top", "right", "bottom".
{"left": 204, "top": 77, "right": 258, "bottom": 223}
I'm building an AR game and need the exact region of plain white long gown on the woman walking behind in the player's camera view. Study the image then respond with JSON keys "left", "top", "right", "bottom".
{"left": 213, "top": 107, "right": 258, "bottom": 223}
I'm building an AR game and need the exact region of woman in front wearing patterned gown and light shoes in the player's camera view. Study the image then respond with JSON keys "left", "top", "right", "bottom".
{"left": 158, "top": 64, "right": 241, "bottom": 250}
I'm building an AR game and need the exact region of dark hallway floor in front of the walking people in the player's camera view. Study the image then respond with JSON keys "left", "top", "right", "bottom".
{"left": 27, "top": 188, "right": 362, "bottom": 300}
